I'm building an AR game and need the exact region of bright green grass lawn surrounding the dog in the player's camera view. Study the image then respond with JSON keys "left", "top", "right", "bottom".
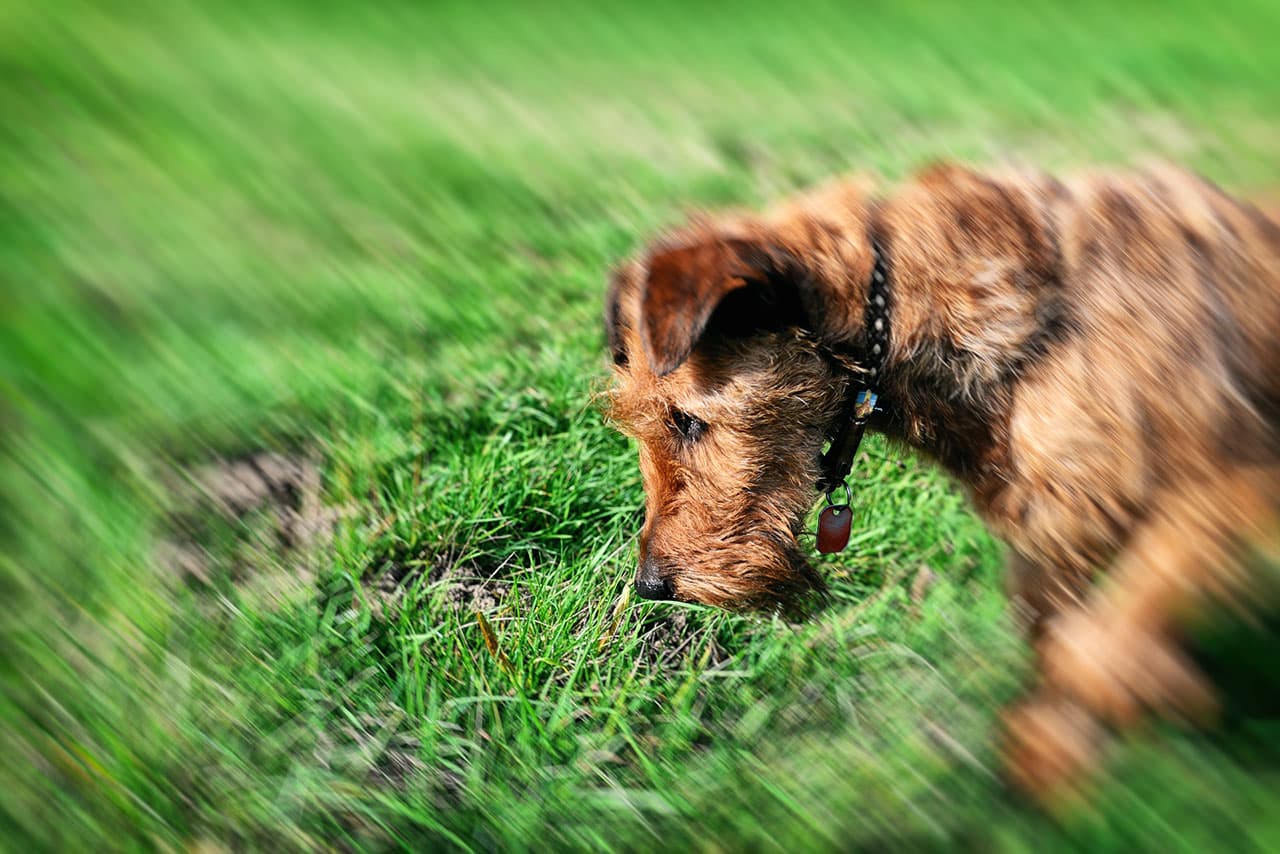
{"left": 0, "top": 0, "right": 1280, "bottom": 850}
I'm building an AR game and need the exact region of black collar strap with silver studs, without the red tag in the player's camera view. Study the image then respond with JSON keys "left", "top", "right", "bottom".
{"left": 818, "top": 238, "right": 888, "bottom": 495}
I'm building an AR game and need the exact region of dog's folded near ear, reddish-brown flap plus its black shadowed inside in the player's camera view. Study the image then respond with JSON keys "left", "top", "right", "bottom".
{"left": 640, "top": 238, "right": 799, "bottom": 376}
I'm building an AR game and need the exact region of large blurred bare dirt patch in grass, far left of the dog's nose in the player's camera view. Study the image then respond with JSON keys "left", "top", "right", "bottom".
{"left": 156, "top": 452, "right": 343, "bottom": 593}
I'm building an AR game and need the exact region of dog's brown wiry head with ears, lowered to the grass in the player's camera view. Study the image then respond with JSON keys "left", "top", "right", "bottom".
{"left": 605, "top": 190, "right": 872, "bottom": 607}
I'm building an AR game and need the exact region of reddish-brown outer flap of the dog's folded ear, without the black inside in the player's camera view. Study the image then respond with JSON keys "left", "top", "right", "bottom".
{"left": 640, "top": 238, "right": 785, "bottom": 376}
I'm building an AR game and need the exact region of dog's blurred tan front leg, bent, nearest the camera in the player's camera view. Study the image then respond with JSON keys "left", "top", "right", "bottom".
{"left": 1007, "top": 466, "right": 1280, "bottom": 796}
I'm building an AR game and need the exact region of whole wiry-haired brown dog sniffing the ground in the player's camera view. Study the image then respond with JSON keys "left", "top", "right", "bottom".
{"left": 607, "top": 166, "right": 1280, "bottom": 794}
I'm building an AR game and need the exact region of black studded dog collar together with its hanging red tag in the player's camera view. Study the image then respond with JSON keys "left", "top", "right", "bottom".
{"left": 818, "top": 238, "right": 888, "bottom": 554}
